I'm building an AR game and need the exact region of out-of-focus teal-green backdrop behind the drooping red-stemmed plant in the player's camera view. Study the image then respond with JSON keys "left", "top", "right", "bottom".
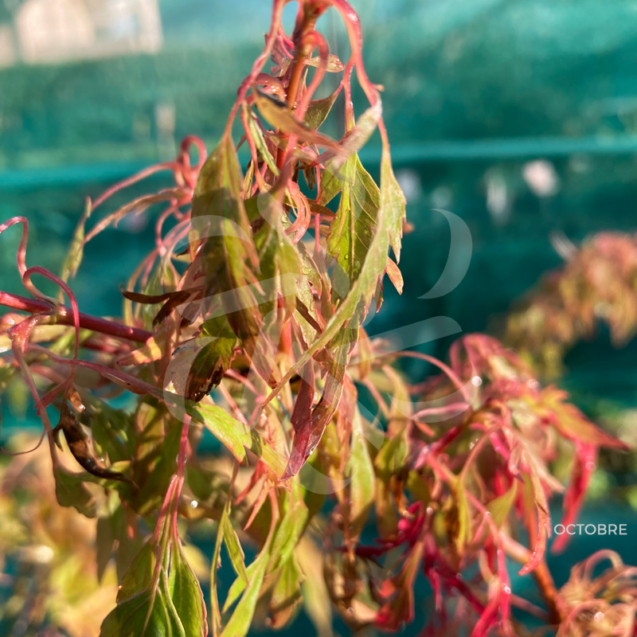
{"left": 0, "top": 0, "right": 637, "bottom": 632}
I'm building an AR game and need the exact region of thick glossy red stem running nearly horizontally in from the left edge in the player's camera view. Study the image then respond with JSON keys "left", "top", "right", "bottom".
{"left": 0, "top": 292, "right": 152, "bottom": 343}
